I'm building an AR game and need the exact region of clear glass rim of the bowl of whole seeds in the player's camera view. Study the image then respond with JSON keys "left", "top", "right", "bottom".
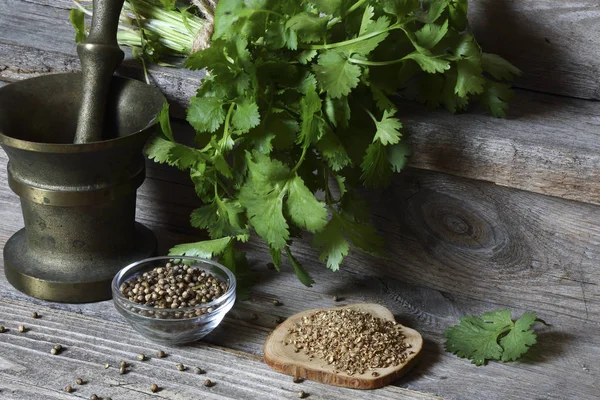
{"left": 111, "top": 255, "right": 237, "bottom": 321}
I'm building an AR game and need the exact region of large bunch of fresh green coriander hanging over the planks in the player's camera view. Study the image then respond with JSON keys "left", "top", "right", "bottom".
{"left": 140, "top": 0, "right": 520, "bottom": 285}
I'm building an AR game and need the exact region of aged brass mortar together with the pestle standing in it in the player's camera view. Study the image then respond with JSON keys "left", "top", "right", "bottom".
{"left": 0, "top": 0, "right": 166, "bottom": 303}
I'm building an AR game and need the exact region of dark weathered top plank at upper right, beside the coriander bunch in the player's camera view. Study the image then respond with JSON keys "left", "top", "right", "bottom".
{"left": 469, "top": 0, "right": 600, "bottom": 100}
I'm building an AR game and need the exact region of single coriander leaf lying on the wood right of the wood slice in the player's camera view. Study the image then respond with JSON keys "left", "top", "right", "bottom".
{"left": 444, "top": 309, "right": 544, "bottom": 365}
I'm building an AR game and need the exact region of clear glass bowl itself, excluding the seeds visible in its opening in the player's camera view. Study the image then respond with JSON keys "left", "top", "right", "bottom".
{"left": 112, "top": 256, "right": 236, "bottom": 344}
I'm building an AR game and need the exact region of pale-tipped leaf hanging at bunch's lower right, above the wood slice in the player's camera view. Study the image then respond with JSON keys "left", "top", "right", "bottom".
{"left": 312, "top": 212, "right": 350, "bottom": 271}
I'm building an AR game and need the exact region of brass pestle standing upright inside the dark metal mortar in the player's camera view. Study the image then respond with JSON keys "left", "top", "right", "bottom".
{"left": 73, "top": 0, "right": 124, "bottom": 143}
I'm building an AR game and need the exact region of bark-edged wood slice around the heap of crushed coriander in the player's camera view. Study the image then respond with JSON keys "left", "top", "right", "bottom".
{"left": 264, "top": 303, "right": 423, "bottom": 389}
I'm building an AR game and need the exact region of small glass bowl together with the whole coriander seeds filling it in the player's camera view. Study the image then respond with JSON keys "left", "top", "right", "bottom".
{"left": 112, "top": 256, "right": 236, "bottom": 344}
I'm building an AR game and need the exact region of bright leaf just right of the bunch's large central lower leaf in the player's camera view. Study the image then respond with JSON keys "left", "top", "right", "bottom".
{"left": 285, "top": 176, "right": 327, "bottom": 232}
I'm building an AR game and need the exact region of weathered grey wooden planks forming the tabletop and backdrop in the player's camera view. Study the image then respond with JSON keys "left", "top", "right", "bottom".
{"left": 0, "top": 0, "right": 600, "bottom": 400}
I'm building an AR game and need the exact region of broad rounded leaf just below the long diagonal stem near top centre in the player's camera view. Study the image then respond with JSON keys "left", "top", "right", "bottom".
{"left": 313, "top": 50, "right": 361, "bottom": 99}
